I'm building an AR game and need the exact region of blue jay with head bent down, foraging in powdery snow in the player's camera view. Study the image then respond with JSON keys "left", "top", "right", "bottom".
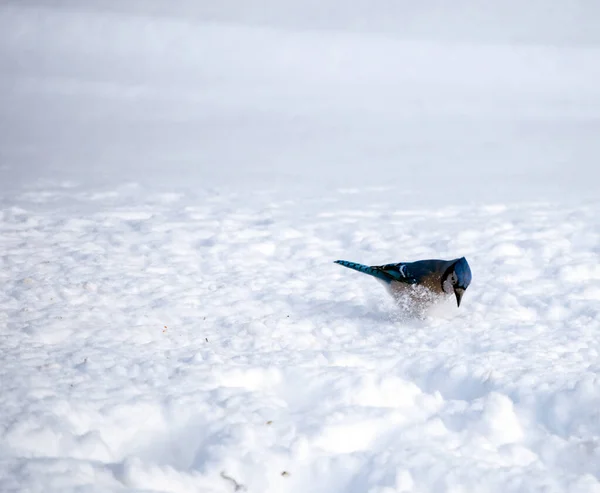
{"left": 335, "top": 257, "right": 471, "bottom": 306}
